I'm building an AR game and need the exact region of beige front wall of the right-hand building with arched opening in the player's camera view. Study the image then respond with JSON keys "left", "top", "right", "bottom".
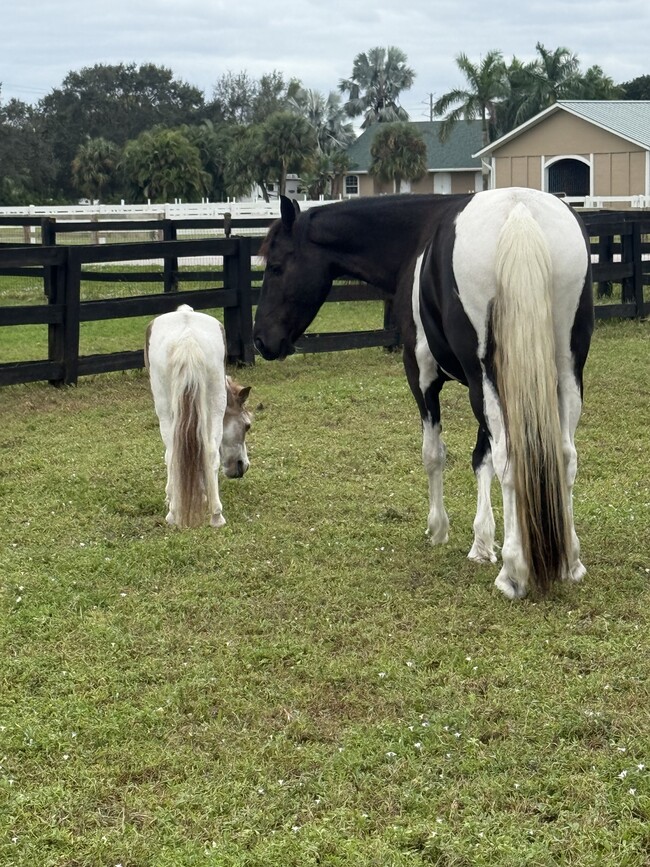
{"left": 493, "top": 111, "right": 645, "bottom": 196}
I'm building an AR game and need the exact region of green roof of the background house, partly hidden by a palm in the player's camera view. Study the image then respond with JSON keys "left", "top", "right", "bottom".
{"left": 346, "top": 120, "right": 481, "bottom": 173}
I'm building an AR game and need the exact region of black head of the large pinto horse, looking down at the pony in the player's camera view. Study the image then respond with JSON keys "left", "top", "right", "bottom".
{"left": 253, "top": 196, "right": 332, "bottom": 359}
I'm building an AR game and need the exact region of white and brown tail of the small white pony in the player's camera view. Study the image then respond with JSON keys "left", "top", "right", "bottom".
{"left": 169, "top": 334, "right": 215, "bottom": 527}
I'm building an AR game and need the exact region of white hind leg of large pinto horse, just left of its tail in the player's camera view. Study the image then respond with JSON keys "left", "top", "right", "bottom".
{"left": 483, "top": 379, "right": 529, "bottom": 599}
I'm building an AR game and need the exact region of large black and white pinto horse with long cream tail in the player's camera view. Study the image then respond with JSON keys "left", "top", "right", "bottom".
{"left": 254, "top": 188, "right": 593, "bottom": 598}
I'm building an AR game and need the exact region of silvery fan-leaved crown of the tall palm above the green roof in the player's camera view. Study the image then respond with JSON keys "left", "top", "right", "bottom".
{"left": 339, "top": 45, "right": 415, "bottom": 129}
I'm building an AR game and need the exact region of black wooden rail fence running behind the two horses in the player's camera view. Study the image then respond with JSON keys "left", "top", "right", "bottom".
{"left": 0, "top": 211, "right": 650, "bottom": 385}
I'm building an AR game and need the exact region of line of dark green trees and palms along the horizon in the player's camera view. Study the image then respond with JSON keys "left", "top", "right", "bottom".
{"left": 0, "top": 49, "right": 650, "bottom": 205}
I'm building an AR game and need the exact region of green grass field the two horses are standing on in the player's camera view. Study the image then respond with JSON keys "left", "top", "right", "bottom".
{"left": 0, "top": 305, "right": 650, "bottom": 867}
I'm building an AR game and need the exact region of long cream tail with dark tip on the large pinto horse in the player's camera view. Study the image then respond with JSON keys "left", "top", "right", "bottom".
{"left": 491, "top": 203, "right": 570, "bottom": 594}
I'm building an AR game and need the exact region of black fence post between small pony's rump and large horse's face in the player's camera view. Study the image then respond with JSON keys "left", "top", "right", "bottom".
{"left": 223, "top": 237, "right": 255, "bottom": 366}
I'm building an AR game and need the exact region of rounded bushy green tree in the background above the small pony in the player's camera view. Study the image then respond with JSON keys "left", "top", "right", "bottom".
{"left": 122, "top": 127, "right": 209, "bottom": 202}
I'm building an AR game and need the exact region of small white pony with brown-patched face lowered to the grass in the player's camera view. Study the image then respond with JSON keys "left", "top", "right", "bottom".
{"left": 144, "top": 304, "right": 251, "bottom": 527}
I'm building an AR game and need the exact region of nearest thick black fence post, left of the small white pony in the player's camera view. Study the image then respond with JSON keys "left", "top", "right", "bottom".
{"left": 48, "top": 247, "right": 81, "bottom": 386}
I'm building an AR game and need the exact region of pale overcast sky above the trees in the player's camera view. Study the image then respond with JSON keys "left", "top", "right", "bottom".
{"left": 0, "top": 0, "right": 650, "bottom": 120}
